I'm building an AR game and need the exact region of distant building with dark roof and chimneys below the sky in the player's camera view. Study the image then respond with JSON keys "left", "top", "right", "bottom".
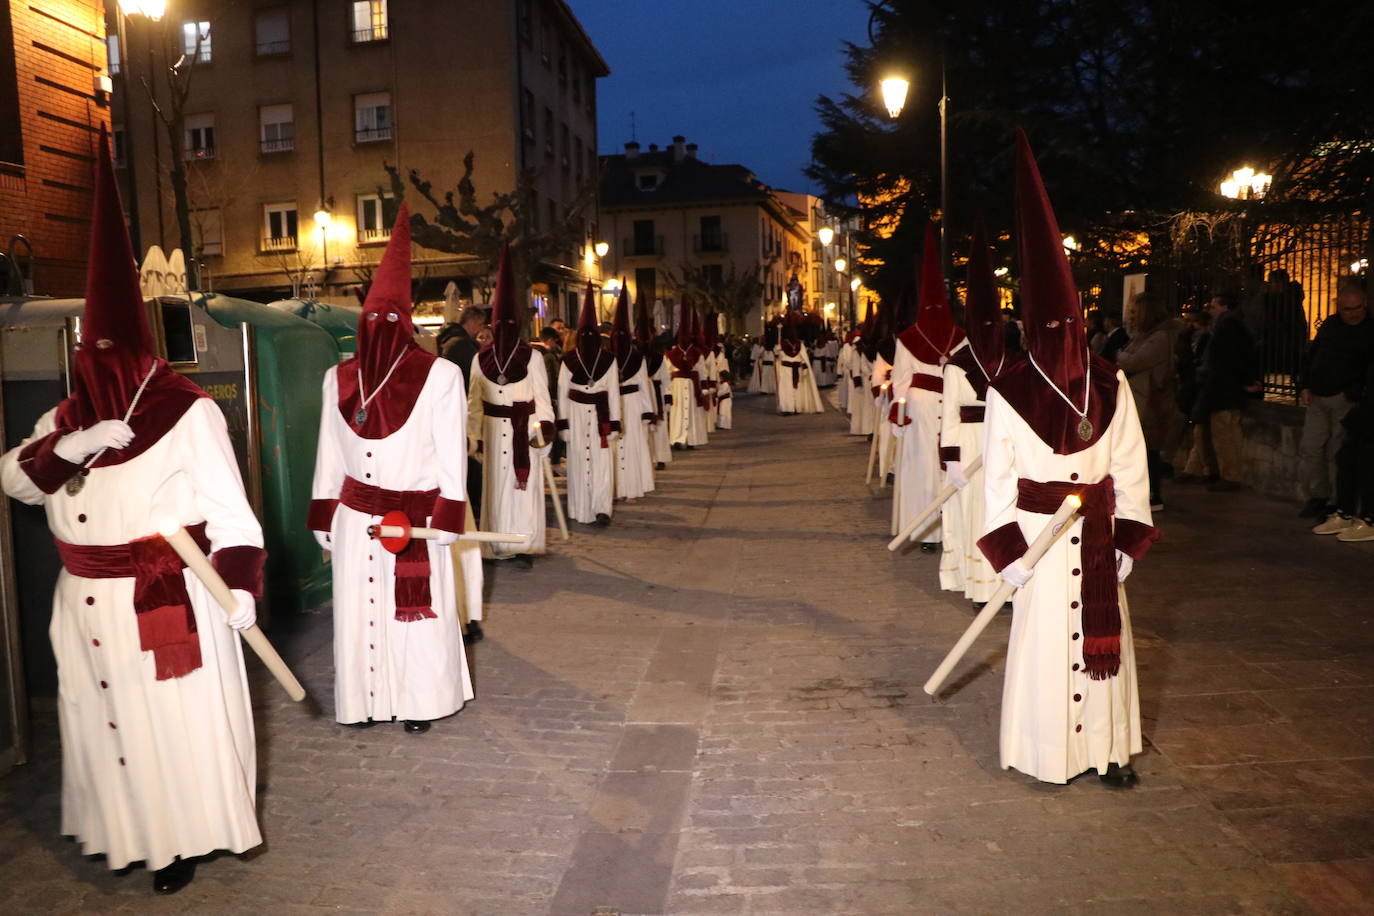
{"left": 600, "top": 137, "right": 812, "bottom": 334}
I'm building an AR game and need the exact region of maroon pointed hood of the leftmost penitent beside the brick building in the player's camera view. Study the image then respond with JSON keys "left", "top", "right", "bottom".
{"left": 44, "top": 129, "right": 206, "bottom": 467}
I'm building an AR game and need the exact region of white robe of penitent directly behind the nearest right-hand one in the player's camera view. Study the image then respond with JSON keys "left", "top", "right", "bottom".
{"left": 940, "top": 363, "right": 1000, "bottom": 602}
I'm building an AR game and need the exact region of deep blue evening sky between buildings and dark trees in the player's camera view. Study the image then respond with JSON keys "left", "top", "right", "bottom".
{"left": 572, "top": 0, "right": 868, "bottom": 191}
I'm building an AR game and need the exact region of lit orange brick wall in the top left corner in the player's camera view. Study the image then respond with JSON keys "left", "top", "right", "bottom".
{"left": 0, "top": 0, "right": 110, "bottom": 295}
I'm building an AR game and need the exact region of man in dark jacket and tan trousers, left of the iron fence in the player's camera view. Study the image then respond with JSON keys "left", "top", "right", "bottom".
{"left": 1187, "top": 293, "right": 1260, "bottom": 490}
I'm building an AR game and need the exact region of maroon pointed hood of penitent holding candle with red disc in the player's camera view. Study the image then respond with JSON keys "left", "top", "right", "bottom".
{"left": 337, "top": 201, "right": 437, "bottom": 439}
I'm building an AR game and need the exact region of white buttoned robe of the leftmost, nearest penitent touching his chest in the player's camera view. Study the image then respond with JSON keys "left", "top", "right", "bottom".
{"left": 0, "top": 398, "right": 262, "bottom": 869}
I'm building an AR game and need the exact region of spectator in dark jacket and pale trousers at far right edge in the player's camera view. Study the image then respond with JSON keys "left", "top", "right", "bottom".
{"left": 1298, "top": 277, "right": 1374, "bottom": 519}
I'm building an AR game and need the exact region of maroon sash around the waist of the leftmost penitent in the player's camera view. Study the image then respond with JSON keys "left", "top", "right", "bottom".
{"left": 52, "top": 522, "right": 210, "bottom": 681}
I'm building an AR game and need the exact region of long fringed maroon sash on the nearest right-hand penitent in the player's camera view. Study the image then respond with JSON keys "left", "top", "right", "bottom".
{"left": 1017, "top": 477, "right": 1121, "bottom": 681}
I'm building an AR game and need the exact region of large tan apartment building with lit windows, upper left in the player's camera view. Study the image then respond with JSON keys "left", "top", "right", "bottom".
{"left": 110, "top": 0, "right": 609, "bottom": 321}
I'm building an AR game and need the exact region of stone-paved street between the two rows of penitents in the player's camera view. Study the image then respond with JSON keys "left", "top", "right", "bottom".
{"left": 0, "top": 397, "right": 1374, "bottom": 916}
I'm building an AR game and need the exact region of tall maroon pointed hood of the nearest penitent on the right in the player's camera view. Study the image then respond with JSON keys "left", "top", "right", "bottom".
{"left": 992, "top": 130, "right": 1117, "bottom": 455}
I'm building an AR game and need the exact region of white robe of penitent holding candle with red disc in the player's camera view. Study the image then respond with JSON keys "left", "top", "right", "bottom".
{"left": 312, "top": 360, "right": 481, "bottom": 722}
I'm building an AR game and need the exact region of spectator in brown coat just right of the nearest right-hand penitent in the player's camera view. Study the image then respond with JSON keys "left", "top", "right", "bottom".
{"left": 1109, "top": 291, "right": 1183, "bottom": 512}
